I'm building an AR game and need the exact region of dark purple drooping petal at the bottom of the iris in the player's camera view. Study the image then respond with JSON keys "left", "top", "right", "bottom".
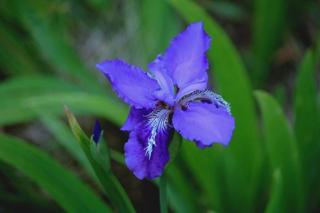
{"left": 124, "top": 118, "right": 171, "bottom": 179}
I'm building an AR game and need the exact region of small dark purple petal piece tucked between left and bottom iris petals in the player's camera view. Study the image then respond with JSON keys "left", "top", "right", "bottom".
{"left": 121, "top": 107, "right": 151, "bottom": 131}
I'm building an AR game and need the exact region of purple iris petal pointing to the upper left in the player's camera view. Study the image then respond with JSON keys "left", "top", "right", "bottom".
{"left": 97, "top": 59, "right": 159, "bottom": 109}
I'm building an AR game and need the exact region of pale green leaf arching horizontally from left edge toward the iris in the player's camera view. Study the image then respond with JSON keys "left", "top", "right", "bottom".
{"left": 0, "top": 92, "right": 126, "bottom": 125}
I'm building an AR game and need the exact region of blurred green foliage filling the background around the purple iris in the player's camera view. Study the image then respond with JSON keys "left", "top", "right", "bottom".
{"left": 0, "top": 0, "right": 320, "bottom": 213}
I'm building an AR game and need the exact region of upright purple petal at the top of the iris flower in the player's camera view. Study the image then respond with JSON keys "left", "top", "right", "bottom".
{"left": 149, "top": 22, "right": 210, "bottom": 96}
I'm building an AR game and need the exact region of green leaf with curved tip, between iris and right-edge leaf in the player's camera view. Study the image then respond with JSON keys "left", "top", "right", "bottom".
{"left": 255, "top": 91, "right": 305, "bottom": 212}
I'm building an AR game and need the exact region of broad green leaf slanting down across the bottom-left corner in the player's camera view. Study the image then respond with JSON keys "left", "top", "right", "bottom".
{"left": 0, "top": 134, "right": 111, "bottom": 212}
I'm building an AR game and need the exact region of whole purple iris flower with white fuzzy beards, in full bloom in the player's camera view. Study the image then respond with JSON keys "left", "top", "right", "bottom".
{"left": 97, "top": 23, "right": 235, "bottom": 179}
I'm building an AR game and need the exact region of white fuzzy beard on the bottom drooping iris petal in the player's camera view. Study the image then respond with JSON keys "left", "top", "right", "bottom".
{"left": 144, "top": 109, "right": 171, "bottom": 160}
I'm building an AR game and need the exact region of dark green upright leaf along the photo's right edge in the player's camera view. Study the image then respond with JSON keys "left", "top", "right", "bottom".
{"left": 294, "top": 50, "right": 320, "bottom": 211}
